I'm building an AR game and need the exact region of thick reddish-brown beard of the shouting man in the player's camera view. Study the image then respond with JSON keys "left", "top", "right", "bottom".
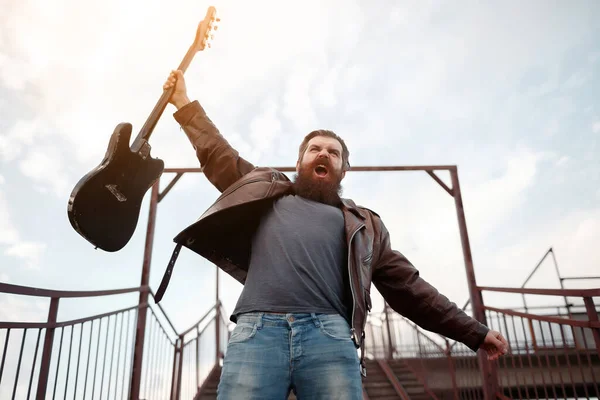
{"left": 293, "top": 159, "right": 342, "bottom": 206}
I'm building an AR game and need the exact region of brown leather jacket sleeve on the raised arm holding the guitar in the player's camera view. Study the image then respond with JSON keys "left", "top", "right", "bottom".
{"left": 173, "top": 100, "right": 255, "bottom": 192}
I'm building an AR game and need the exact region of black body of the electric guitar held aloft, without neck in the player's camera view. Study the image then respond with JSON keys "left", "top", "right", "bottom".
{"left": 67, "top": 123, "right": 164, "bottom": 252}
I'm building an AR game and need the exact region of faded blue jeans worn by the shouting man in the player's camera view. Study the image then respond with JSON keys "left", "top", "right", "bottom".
{"left": 217, "top": 313, "right": 363, "bottom": 400}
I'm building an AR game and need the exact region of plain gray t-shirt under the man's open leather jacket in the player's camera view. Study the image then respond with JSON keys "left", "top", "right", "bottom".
{"left": 233, "top": 195, "right": 348, "bottom": 318}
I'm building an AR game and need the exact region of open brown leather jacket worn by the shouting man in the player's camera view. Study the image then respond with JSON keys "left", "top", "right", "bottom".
{"left": 169, "top": 101, "right": 488, "bottom": 372}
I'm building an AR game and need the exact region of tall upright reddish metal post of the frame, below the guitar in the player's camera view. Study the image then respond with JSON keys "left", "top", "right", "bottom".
{"left": 129, "top": 179, "right": 160, "bottom": 400}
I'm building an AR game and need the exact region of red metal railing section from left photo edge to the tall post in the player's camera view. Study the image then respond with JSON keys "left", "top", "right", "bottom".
{"left": 0, "top": 283, "right": 148, "bottom": 399}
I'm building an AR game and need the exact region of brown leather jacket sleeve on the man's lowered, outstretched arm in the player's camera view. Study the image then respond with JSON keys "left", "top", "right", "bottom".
{"left": 373, "top": 217, "right": 489, "bottom": 351}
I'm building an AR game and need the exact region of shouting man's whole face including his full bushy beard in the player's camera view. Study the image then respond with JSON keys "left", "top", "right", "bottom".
{"left": 294, "top": 136, "right": 346, "bottom": 205}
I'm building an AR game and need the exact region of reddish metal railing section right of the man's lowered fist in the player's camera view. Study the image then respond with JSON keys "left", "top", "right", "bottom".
{"left": 479, "top": 287, "right": 600, "bottom": 399}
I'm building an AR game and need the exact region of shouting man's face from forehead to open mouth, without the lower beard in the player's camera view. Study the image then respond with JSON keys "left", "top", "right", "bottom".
{"left": 296, "top": 136, "right": 346, "bottom": 183}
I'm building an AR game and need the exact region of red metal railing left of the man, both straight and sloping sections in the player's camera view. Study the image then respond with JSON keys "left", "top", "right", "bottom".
{"left": 0, "top": 283, "right": 228, "bottom": 400}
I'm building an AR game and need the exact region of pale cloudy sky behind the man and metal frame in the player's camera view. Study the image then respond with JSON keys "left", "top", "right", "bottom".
{"left": 0, "top": 0, "right": 600, "bottom": 329}
